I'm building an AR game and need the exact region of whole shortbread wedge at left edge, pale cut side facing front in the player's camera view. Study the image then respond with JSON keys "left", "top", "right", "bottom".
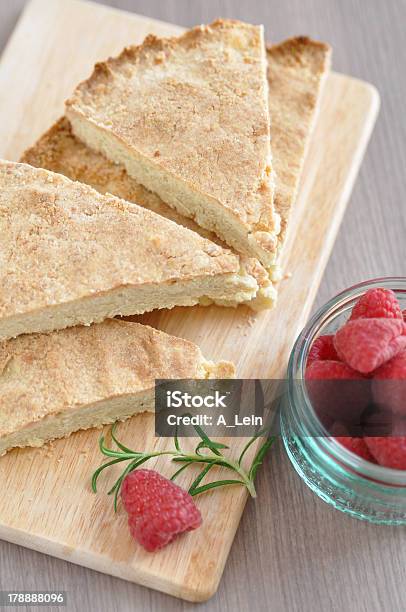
{"left": 0, "top": 161, "right": 258, "bottom": 340}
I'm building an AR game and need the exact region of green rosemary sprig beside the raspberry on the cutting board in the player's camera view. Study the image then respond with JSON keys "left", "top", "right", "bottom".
{"left": 92, "top": 423, "right": 275, "bottom": 510}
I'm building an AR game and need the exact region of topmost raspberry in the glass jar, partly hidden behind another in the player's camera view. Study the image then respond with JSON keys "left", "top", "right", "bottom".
{"left": 350, "top": 288, "right": 402, "bottom": 321}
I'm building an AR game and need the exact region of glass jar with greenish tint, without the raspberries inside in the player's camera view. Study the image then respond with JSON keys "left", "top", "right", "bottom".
{"left": 281, "top": 278, "right": 406, "bottom": 525}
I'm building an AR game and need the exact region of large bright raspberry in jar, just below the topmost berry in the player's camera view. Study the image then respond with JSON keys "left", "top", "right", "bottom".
{"left": 334, "top": 318, "right": 406, "bottom": 374}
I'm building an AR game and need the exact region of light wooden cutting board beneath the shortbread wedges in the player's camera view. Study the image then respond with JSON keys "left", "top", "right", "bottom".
{"left": 0, "top": 0, "right": 379, "bottom": 601}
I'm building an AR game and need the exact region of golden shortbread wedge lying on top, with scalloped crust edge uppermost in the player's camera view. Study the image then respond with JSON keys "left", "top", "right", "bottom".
{"left": 66, "top": 20, "right": 279, "bottom": 267}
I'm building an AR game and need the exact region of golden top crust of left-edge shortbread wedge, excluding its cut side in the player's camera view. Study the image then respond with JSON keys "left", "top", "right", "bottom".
{"left": 0, "top": 161, "right": 255, "bottom": 326}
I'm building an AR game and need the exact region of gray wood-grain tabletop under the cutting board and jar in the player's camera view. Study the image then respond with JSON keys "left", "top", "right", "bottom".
{"left": 0, "top": 0, "right": 406, "bottom": 612}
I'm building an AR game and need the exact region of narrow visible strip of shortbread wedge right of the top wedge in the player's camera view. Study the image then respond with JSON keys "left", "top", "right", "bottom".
{"left": 267, "top": 37, "right": 331, "bottom": 276}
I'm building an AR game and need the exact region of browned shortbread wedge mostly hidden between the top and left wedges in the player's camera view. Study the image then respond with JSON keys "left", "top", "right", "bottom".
{"left": 21, "top": 117, "right": 276, "bottom": 311}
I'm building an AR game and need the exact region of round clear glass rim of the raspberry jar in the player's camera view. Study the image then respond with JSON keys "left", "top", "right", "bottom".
{"left": 288, "top": 277, "right": 406, "bottom": 486}
